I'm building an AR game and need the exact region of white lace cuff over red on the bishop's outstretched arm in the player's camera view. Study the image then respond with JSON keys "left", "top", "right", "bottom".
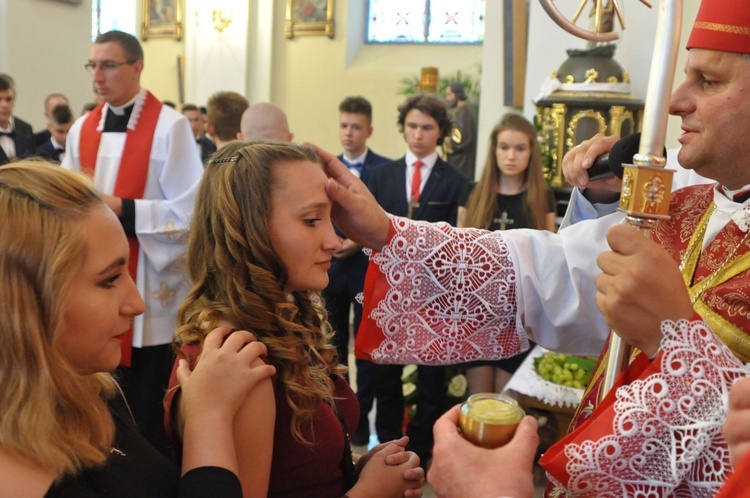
{"left": 360, "top": 217, "right": 529, "bottom": 364}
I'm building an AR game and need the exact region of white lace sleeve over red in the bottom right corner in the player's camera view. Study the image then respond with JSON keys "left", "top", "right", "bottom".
{"left": 548, "top": 320, "right": 748, "bottom": 497}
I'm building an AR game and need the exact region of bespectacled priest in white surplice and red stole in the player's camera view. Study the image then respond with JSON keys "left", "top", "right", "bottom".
{"left": 62, "top": 31, "right": 203, "bottom": 451}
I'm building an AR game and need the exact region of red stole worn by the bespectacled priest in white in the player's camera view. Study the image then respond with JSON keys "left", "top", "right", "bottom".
{"left": 79, "top": 92, "right": 162, "bottom": 366}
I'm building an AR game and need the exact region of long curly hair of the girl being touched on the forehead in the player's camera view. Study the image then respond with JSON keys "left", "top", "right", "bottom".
{"left": 175, "top": 141, "right": 344, "bottom": 442}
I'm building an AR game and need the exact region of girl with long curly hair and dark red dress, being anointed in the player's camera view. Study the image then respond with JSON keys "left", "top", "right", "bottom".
{"left": 170, "top": 142, "right": 424, "bottom": 498}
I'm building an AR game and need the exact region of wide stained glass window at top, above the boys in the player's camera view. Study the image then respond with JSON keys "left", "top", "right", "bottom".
{"left": 367, "top": 0, "right": 485, "bottom": 43}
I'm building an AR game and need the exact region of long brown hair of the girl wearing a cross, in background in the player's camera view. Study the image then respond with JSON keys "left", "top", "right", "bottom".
{"left": 464, "top": 113, "right": 549, "bottom": 229}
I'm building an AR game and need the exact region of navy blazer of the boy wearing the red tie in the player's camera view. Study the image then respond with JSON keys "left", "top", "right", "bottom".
{"left": 367, "top": 157, "right": 469, "bottom": 226}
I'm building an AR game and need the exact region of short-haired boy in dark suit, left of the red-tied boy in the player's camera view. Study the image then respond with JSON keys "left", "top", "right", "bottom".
{"left": 323, "top": 97, "right": 391, "bottom": 446}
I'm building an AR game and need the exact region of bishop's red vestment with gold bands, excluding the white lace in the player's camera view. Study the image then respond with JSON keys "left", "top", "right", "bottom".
{"left": 539, "top": 185, "right": 750, "bottom": 497}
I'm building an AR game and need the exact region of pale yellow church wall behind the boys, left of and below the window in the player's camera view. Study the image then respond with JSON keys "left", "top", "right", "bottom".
{"left": 271, "top": 1, "right": 482, "bottom": 158}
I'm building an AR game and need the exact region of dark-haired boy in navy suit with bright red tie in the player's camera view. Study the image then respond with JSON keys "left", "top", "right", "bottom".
{"left": 367, "top": 94, "right": 469, "bottom": 465}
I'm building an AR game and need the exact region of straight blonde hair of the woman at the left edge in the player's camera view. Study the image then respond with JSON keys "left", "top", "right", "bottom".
{"left": 0, "top": 160, "right": 114, "bottom": 473}
